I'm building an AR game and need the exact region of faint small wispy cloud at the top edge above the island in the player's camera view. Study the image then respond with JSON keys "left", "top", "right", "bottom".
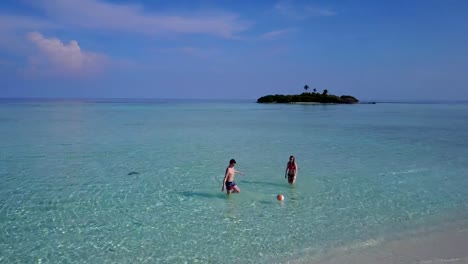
{"left": 274, "top": 0, "right": 337, "bottom": 20}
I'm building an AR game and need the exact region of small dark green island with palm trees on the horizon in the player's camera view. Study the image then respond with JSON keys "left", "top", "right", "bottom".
{"left": 257, "top": 85, "right": 359, "bottom": 104}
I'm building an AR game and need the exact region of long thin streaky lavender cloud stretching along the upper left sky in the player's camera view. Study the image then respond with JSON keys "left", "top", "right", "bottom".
{"left": 34, "top": 0, "right": 250, "bottom": 38}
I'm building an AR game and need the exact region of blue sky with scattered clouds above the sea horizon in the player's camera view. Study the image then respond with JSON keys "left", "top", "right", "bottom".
{"left": 0, "top": 0, "right": 468, "bottom": 100}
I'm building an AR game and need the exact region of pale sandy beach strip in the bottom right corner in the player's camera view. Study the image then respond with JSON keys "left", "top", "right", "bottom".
{"left": 287, "top": 219, "right": 468, "bottom": 264}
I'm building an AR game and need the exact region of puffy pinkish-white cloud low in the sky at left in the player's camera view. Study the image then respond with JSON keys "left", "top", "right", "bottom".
{"left": 26, "top": 31, "right": 107, "bottom": 76}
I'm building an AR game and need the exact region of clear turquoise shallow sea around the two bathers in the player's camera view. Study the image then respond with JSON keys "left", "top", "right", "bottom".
{"left": 0, "top": 100, "right": 468, "bottom": 263}
